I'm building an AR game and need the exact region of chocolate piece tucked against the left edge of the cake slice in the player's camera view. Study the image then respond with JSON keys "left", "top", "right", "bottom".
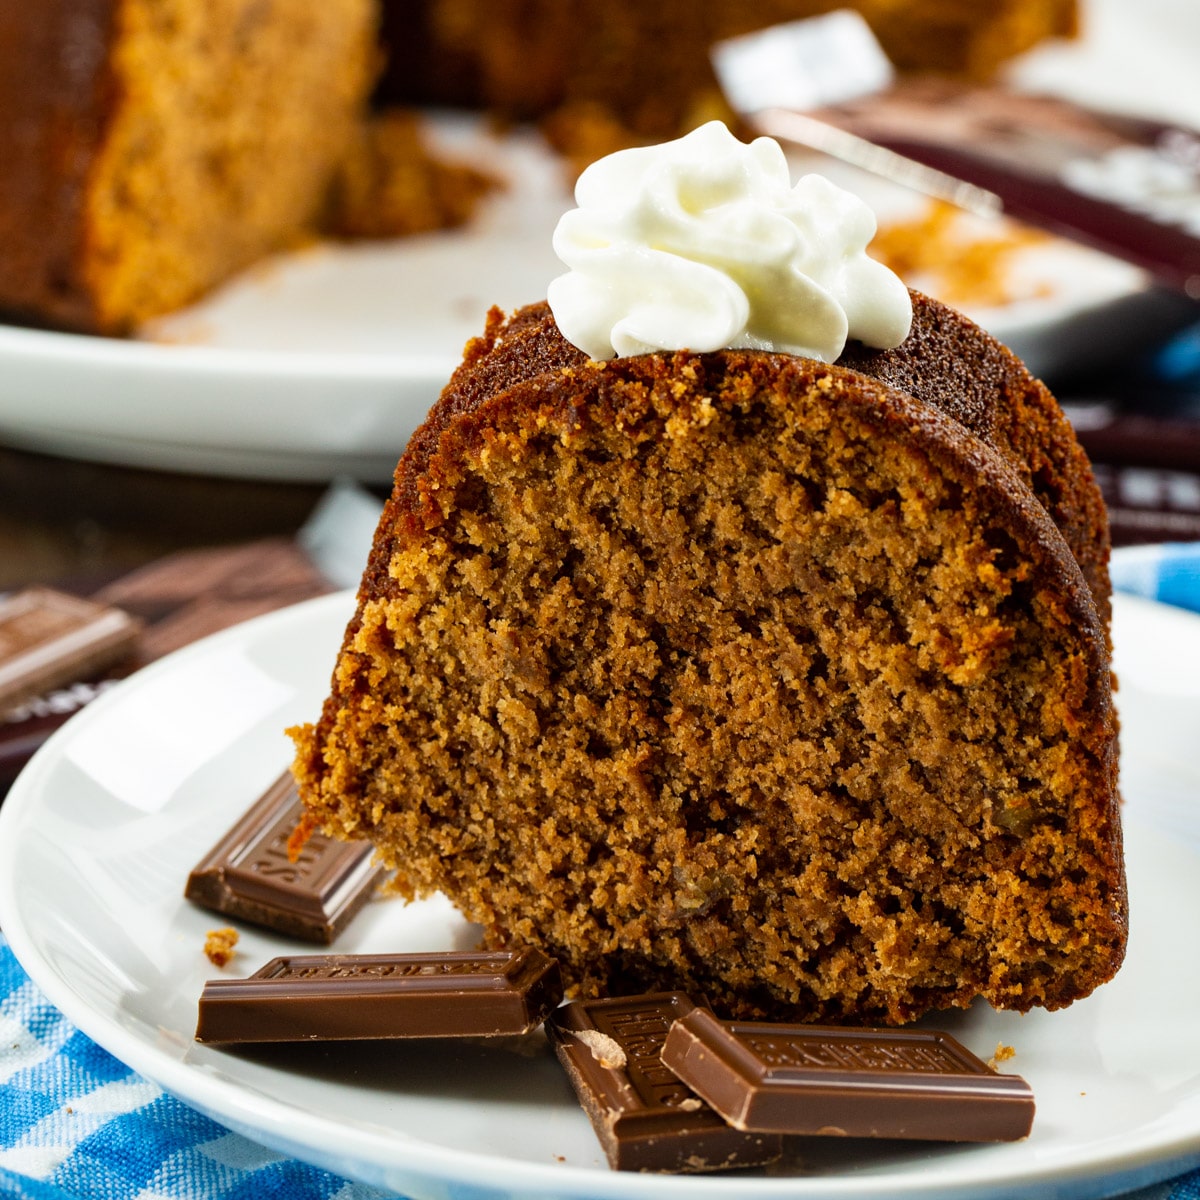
{"left": 184, "top": 772, "right": 383, "bottom": 944}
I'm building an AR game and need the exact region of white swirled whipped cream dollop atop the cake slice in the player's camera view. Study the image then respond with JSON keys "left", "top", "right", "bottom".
{"left": 547, "top": 121, "right": 912, "bottom": 362}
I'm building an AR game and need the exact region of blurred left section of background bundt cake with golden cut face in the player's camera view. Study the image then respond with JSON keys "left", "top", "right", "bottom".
{"left": 0, "top": 0, "right": 378, "bottom": 332}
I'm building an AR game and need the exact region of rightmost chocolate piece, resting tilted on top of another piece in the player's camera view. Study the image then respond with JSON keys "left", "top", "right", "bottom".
{"left": 662, "top": 1008, "right": 1033, "bottom": 1141}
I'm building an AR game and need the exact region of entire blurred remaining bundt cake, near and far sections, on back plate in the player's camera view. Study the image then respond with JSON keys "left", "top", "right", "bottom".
{"left": 0, "top": 0, "right": 1074, "bottom": 334}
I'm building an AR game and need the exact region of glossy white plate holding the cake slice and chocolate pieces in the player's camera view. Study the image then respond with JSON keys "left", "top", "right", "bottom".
{"left": 0, "top": 585, "right": 1200, "bottom": 1200}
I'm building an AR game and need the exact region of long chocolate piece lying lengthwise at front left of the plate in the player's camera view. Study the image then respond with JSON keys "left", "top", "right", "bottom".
{"left": 196, "top": 949, "right": 563, "bottom": 1044}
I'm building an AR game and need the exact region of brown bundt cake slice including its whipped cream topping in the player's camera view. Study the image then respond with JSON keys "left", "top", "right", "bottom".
{"left": 294, "top": 126, "right": 1126, "bottom": 1022}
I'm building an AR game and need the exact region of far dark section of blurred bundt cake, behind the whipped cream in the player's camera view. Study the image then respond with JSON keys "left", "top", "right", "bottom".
{"left": 380, "top": 0, "right": 1078, "bottom": 139}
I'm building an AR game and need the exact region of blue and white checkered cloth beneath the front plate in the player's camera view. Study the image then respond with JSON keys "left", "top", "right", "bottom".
{"left": 7, "top": 545, "right": 1200, "bottom": 1200}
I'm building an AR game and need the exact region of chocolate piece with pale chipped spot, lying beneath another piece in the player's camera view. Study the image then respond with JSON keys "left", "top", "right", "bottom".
{"left": 546, "top": 991, "right": 781, "bottom": 1172}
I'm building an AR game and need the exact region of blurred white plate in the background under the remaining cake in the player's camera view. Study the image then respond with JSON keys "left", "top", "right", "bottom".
{"left": 0, "top": 77, "right": 1178, "bottom": 482}
